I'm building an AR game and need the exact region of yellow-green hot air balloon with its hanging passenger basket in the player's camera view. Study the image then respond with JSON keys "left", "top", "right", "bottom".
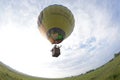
{"left": 38, "top": 4, "right": 75, "bottom": 57}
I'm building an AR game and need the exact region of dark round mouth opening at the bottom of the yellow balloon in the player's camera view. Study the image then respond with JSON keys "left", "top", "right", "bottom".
{"left": 47, "top": 27, "right": 65, "bottom": 44}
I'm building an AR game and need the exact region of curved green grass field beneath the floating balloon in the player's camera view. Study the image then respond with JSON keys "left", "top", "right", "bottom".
{"left": 0, "top": 52, "right": 120, "bottom": 80}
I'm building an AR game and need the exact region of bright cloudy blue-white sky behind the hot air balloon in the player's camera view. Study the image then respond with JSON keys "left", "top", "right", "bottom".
{"left": 0, "top": 0, "right": 120, "bottom": 78}
